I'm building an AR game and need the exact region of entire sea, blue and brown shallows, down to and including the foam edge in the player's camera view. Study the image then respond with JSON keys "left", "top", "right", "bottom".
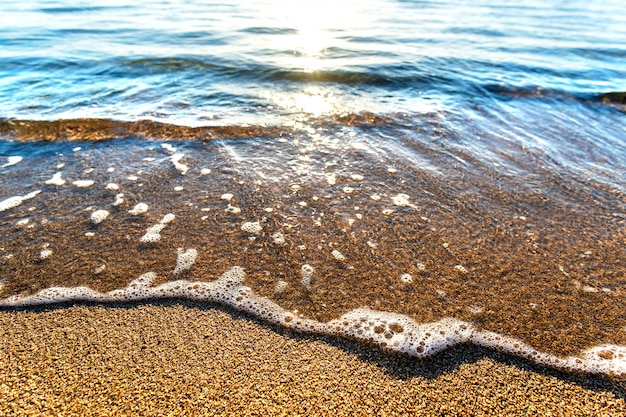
{"left": 0, "top": 0, "right": 626, "bottom": 374}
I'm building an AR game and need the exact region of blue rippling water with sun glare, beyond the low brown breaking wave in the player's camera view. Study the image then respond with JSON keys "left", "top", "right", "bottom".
{"left": 0, "top": 0, "right": 626, "bottom": 124}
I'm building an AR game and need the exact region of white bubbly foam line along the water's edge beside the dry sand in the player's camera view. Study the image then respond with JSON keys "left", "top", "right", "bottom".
{"left": 0, "top": 266, "right": 626, "bottom": 375}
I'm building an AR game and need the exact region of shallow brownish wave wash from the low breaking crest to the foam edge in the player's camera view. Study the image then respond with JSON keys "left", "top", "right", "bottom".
{"left": 0, "top": 107, "right": 626, "bottom": 373}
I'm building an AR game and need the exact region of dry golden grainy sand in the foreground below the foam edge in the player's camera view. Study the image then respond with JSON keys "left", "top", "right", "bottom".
{"left": 0, "top": 301, "right": 626, "bottom": 416}
